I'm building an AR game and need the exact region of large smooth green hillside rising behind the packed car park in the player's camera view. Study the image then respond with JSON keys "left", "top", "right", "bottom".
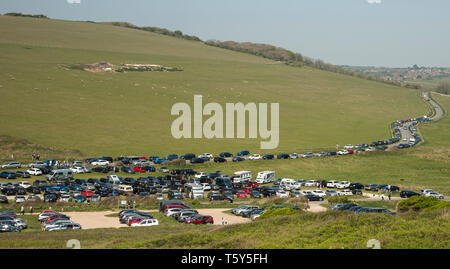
{"left": 0, "top": 17, "right": 427, "bottom": 158}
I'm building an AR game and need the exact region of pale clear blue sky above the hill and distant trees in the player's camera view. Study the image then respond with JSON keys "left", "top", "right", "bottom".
{"left": 0, "top": 0, "right": 450, "bottom": 67}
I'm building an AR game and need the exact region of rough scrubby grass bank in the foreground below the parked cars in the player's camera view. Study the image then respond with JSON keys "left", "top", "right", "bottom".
{"left": 0, "top": 210, "right": 450, "bottom": 249}
